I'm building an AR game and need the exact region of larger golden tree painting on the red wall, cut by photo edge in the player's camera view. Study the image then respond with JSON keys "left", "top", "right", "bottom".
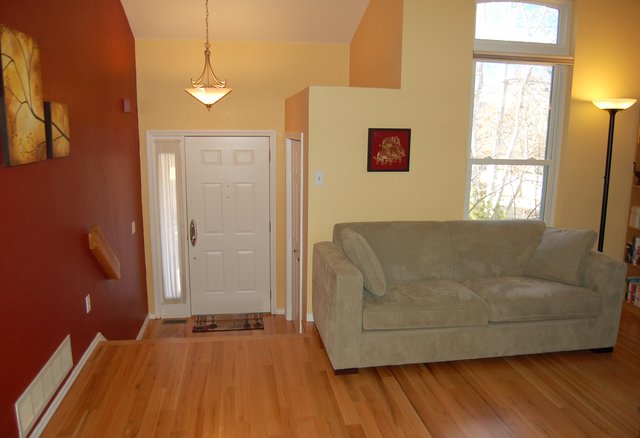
{"left": 0, "top": 25, "right": 47, "bottom": 166}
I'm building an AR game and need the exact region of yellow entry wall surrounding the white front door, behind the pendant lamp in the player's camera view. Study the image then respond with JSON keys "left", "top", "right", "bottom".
{"left": 136, "top": 40, "right": 349, "bottom": 313}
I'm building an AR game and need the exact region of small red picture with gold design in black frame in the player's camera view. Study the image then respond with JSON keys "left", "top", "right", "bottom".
{"left": 367, "top": 128, "right": 411, "bottom": 172}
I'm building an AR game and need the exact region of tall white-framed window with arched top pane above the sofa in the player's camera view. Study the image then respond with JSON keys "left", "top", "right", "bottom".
{"left": 466, "top": 0, "right": 572, "bottom": 219}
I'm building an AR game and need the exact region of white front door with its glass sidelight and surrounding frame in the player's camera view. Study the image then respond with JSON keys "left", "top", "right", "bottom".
{"left": 147, "top": 131, "right": 276, "bottom": 318}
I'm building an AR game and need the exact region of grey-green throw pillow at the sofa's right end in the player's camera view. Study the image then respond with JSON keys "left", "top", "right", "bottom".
{"left": 524, "top": 228, "right": 596, "bottom": 286}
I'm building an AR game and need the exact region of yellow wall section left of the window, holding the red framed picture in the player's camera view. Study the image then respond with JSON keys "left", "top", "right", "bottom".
{"left": 307, "top": 0, "right": 475, "bottom": 310}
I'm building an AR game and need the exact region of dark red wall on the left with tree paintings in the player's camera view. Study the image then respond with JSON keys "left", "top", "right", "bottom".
{"left": 0, "top": 0, "right": 147, "bottom": 437}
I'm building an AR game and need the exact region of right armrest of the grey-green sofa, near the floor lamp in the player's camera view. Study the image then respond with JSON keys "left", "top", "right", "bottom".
{"left": 582, "top": 251, "right": 627, "bottom": 346}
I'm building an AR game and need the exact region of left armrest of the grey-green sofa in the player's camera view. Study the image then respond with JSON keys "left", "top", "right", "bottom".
{"left": 312, "top": 242, "right": 364, "bottom": 370}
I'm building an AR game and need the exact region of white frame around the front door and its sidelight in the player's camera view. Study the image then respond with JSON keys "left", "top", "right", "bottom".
{"left": 147, "top": 130, "right": 278, "bottom": 318}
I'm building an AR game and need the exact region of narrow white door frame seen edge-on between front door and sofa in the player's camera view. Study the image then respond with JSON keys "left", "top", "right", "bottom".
{"left": 285, "top": 132, "right": 307, "bottom": 321}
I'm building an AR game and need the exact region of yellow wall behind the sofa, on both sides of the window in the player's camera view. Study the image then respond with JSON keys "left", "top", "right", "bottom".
{"left": 294, "top": 0, "right": 640, "bottom": 310}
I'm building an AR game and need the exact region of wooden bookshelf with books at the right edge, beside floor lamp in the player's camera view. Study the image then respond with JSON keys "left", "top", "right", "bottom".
{"left": 625, "top": 118, "right": 640, "bottom": 306}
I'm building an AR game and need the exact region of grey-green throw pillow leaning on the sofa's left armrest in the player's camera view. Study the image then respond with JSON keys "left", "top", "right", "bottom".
{"left": 342, "top": 228, "right": 387, "bottom": 296}
